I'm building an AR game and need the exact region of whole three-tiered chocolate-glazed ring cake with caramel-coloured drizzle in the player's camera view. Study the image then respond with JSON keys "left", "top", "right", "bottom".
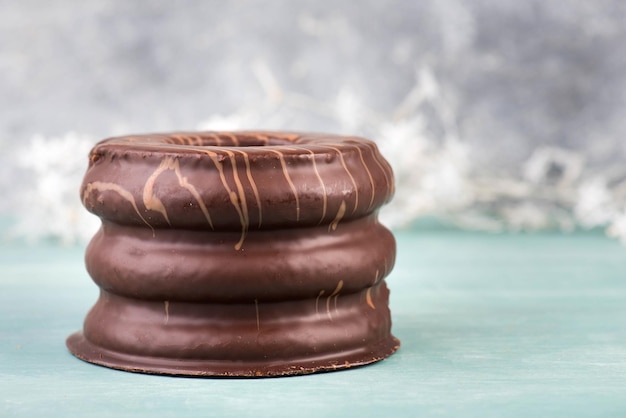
{"left": 67, "top": 132, "right": 400, "bottom": 376}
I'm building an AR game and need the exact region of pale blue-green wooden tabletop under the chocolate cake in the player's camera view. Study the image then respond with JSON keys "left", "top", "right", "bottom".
{"left": 0, "top": 231, "right": 626, "bottom": 417}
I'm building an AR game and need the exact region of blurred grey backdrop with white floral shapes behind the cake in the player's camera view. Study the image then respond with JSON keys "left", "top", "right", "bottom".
{"left": 0, "top": 0, "right": 626, "bottom": 243}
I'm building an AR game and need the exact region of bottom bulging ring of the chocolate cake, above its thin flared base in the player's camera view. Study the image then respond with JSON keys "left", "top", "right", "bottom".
{"left": 78, "top": 281, "right": 391, "bottom": 362}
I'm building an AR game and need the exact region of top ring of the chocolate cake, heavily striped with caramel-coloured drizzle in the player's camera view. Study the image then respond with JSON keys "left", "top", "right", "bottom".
{"left": 81, "top": 132, "right": 393, "bottom": 235}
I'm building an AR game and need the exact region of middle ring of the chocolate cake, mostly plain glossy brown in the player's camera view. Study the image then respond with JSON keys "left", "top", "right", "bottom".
{"left": 86, "top": 216, "right": 396, "bottom": 303}
